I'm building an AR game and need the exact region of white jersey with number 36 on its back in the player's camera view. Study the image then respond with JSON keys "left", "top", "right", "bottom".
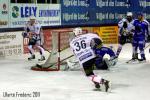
{"left": 70, "top": 33, "right": 100, "bottom": 65}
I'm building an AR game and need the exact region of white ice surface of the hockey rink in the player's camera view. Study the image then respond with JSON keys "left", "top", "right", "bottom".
{"left": 0, "top": 44, "right": 150, "bottom": 100}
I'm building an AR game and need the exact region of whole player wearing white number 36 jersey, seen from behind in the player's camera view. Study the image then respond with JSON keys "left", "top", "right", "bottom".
{"left": 70, "top": 28, "right": 109, "bottom": 92}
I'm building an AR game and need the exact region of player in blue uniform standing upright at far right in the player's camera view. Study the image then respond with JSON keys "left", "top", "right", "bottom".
{"left": 132, "top": 13, "right": 149, "bottom": 61}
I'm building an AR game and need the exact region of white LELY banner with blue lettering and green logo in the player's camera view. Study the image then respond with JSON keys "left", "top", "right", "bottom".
{"left": 9, "top": 4, "right": 61, "bottom": 28}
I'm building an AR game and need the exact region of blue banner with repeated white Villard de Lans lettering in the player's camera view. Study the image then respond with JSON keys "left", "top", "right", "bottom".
{"left": 61, "top": 0, "right": 150, "bottom": 25}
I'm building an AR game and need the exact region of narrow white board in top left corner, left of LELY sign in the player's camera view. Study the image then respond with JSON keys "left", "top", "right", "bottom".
{"left": 0, "top": 0, "right": 9, "bottom": 28}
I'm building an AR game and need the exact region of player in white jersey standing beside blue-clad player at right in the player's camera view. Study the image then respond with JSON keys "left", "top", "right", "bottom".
{"left": 116, "top": 12, "right": 134, "bottom": 56}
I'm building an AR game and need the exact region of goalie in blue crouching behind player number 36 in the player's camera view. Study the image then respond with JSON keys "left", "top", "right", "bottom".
{"left": 91, "top": 38, "right": 118, "bottom": 70}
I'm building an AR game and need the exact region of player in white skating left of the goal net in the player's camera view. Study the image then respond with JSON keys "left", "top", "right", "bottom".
{"left": 23, "top": 16, "right": 45, "bottom": 61}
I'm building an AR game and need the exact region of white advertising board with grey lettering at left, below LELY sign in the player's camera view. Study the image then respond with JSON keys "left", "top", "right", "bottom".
{"left": 0, "top": 32, "right": 23, "bottom": 57}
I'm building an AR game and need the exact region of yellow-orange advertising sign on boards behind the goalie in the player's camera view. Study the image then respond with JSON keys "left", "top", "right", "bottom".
{"left": 94, "top": 26, "right": 118, "bottom": 44}
